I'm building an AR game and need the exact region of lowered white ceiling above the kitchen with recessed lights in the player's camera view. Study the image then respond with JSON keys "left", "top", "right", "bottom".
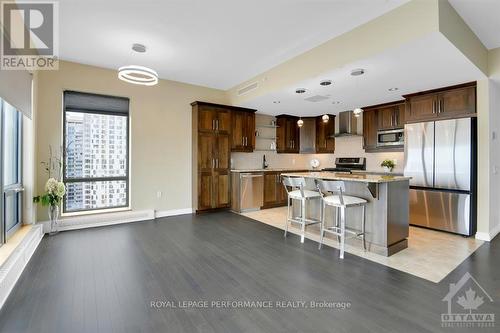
{"left": 243, "top": 33, "right": 484, "bottom": 116}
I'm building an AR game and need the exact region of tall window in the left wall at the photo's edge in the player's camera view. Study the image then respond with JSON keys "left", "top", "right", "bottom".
{"left": 0, "top": 100, "right": 23, "bottom": 243}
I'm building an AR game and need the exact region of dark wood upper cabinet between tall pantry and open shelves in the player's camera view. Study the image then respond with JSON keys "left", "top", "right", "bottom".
{"left": 231, "top": 111, "right": 255, "bottom": 152}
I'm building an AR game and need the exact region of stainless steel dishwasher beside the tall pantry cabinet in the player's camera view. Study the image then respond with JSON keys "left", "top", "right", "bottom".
{"left": 238, "top": 173, "right": 264, "bottom": 212}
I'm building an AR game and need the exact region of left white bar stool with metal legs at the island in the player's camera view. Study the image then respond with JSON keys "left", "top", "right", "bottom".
{"left": 283, "top": 177, "right": 321, "bottom": 243}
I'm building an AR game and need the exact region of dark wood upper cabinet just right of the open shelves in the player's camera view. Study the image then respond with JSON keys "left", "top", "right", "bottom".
{"left": 276, "top": 115, "right": 300, "bottom": 154}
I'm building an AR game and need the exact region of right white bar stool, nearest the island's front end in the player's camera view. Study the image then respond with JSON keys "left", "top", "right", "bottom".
{"left": 316, "top": 180, "right": 368, "bottom": 259}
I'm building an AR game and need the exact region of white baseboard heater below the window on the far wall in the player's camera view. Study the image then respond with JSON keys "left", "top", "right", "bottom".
{"left": 39, "top": 210, "right": 155, "bottom": 233}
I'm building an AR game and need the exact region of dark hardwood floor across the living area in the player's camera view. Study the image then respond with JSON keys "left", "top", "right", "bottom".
{"left": 0, "top": 212, "right": 500, "bottom": 333}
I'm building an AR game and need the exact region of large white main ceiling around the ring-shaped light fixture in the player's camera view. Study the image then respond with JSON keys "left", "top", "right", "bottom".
{"left": 59, "top": 0, "right": 408, "bottom": 89}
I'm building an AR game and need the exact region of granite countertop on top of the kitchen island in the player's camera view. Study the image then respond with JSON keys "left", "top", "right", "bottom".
{"left": 283, "top": 172, "right": 411, "bottom": 183}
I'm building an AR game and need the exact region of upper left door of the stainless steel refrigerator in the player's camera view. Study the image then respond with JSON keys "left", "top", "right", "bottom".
{"left": 404, "top": 122, "right": 434, "bottom": 187}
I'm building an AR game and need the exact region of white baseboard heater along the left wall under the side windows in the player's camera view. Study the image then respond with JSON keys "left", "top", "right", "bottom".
{"left": 0, "top": 225, "right": 43, "bottom": 308}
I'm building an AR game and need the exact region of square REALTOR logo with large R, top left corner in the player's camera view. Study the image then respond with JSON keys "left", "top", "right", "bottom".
{"left": 0, "top": 1, "right": 59, "bottom": 70}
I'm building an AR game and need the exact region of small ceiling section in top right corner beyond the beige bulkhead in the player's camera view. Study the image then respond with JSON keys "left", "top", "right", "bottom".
{"left": 448, "top": 0, "right": 500, "bottom": 50}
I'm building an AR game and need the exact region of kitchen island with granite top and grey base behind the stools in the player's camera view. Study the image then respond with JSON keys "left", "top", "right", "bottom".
{"left": 282, "top": 172, "right": 410, "bottom": 256}
